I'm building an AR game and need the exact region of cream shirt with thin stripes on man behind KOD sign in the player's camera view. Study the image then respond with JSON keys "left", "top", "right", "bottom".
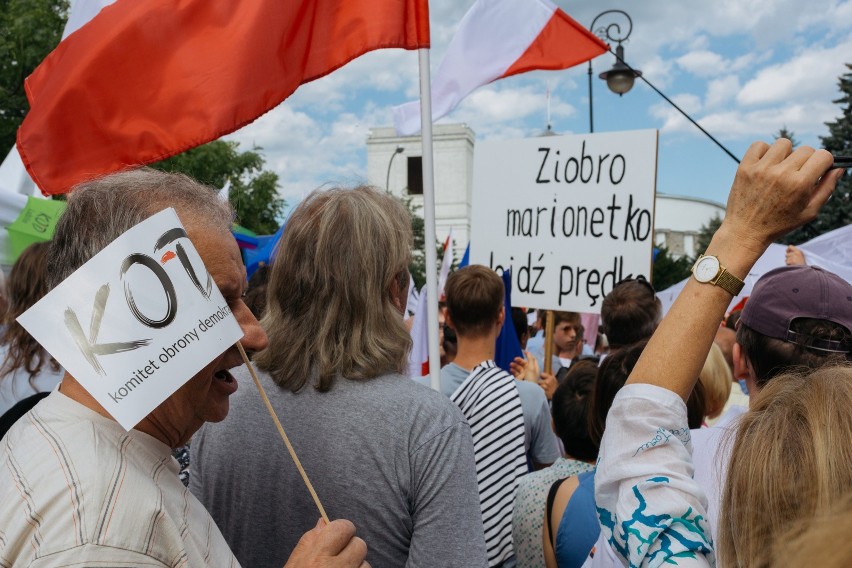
{"left": 0, "top": 391, "right": 240, "bottom": 567}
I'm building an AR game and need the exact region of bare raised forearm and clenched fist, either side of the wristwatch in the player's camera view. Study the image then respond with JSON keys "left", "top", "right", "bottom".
{"left": 627, "top": 138, "right": 844, "bottom": 401}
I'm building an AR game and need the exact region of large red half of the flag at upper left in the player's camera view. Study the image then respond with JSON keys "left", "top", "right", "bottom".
{"left": 18, "top": 0, "right": 429, "bottom": 194}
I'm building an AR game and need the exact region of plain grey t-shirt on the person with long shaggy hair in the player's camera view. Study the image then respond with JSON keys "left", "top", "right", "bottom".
{"left": 190, "top": 367, "right": 487, "bottom": 568}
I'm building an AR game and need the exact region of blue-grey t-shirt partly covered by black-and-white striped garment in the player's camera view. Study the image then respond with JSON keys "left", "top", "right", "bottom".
{"left": 441, "top": 363, "right": 561, "bottom": 465}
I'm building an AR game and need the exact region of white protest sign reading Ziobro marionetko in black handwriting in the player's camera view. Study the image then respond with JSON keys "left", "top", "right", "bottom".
{"left": 470, "top": 130, "right": 657, "bottom": 313}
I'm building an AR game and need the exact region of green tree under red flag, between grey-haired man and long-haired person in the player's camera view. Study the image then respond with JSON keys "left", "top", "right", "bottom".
{"left": 151, "top": 140, "right": 285, "bottom": 235}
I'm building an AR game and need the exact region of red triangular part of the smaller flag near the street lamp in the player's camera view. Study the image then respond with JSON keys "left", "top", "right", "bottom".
{"left": 502, "top": 8, "right": 609, "bottom": 77}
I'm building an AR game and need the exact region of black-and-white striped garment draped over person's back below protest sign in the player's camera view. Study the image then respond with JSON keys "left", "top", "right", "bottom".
{"left": 450, "top": 360, "right": 527, "bottom": 566}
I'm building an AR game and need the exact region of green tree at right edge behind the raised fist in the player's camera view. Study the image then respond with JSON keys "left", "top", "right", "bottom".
{"left": 782, "top": 63, "right": 852, "bottom": 244}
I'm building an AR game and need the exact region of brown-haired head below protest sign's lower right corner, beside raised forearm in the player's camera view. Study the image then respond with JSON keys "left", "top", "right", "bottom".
{"left": 601, "top": 276, "right": 662, "bottom": 349}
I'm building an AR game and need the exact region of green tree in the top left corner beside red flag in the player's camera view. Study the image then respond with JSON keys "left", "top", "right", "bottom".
{"left": 0, "top": 0, "right": 68, "bottom": 151}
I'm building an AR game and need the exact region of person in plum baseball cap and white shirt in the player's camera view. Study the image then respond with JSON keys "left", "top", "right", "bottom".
{"left": 692, "top": 265, "right": 852, "bottom": 540}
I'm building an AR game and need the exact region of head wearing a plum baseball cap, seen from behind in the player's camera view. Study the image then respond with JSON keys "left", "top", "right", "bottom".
{"left": 737, "top": 266, "right": 852, "bottom": 387}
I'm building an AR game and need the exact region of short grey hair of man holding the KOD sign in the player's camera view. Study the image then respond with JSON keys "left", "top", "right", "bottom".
{"left": 48, "top": 168, "right": 234, "bottom": 289}
